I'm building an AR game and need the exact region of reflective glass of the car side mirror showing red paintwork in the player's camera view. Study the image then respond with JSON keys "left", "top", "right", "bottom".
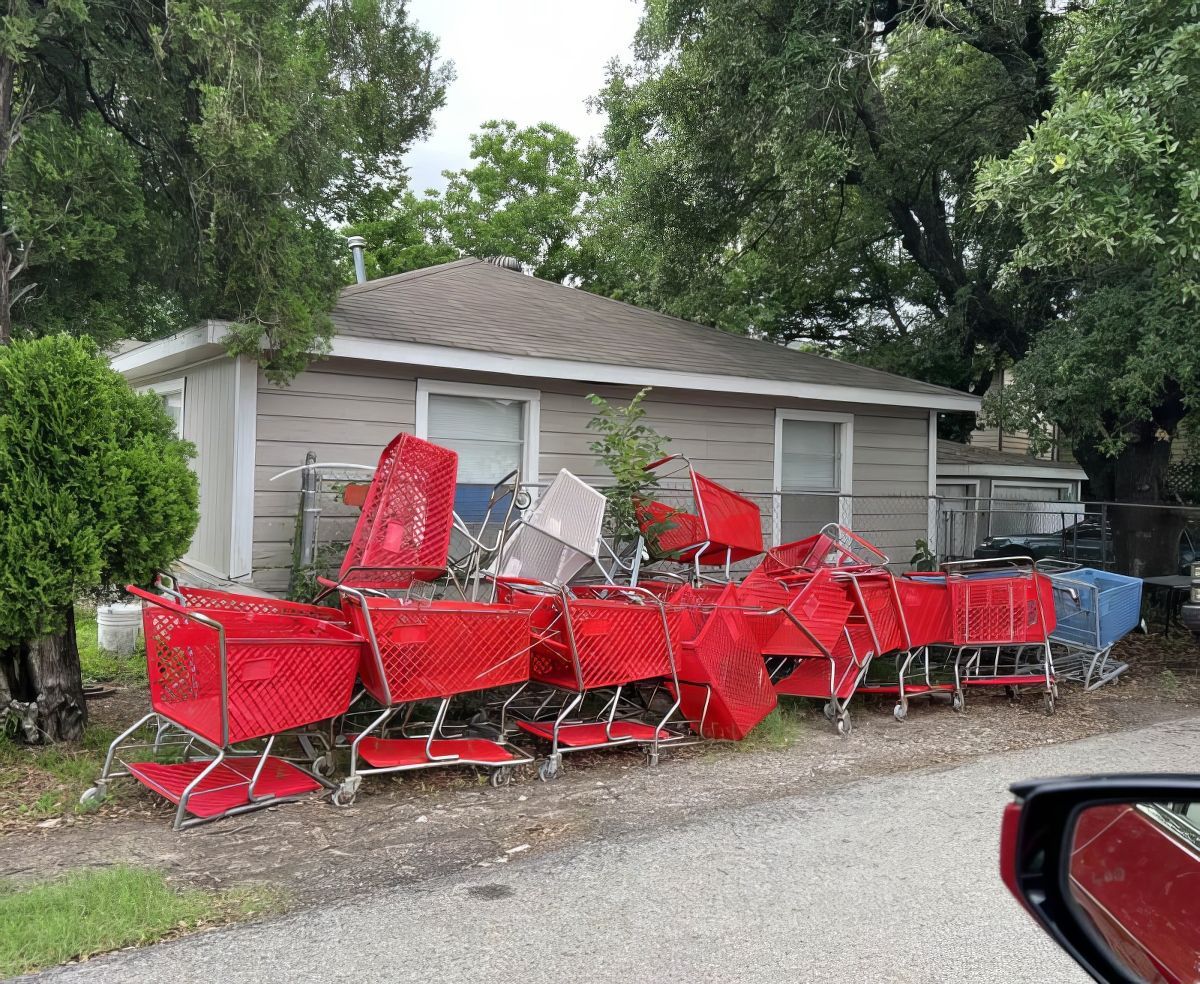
{"left": 1067, "top": 800, "right": 1200, "bottom": 984}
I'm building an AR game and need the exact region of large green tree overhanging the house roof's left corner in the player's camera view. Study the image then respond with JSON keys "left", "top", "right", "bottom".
{"left": 0, "top": 0, "right": 450, "bottom": 378}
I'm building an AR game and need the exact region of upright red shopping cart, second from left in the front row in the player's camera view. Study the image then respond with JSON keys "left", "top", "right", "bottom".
{"left": 334, "top": 584, "right": 533, "bottom": 806}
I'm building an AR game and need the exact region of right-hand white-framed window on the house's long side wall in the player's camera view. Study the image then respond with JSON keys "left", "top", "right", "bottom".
{"left": 775, "top": 410, "right": 854, "bottom": 542}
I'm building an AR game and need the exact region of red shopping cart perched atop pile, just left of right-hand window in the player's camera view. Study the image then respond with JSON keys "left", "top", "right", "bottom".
{"left": 637, "top": 455, "right": 762, "bottom": 581}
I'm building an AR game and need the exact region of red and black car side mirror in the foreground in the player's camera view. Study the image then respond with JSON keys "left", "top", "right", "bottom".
{"left": 1001, "top": 775, "right": 1200, "bottom": 984}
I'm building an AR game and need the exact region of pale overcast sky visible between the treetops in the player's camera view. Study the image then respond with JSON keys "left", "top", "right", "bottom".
{"left": 406, "top": 0, "right": 642, "bottom": 192}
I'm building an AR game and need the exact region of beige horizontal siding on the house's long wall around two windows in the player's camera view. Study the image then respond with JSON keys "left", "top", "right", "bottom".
{"left": 253, "top": 360, "right": 929, "bottom": 592}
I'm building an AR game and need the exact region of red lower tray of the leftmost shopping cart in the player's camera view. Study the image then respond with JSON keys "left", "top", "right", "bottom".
{"left": 128, "top": 756, "right": 320, "bottom": 820}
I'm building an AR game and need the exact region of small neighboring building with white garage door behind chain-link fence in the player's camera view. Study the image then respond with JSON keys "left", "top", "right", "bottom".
{"left": 937, "top": 440, "right": 1087, "bottom": 557}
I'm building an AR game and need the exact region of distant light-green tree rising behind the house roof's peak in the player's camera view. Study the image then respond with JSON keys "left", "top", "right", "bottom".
{"left": 347, "top": 120, "right": 588, "bottom": 281}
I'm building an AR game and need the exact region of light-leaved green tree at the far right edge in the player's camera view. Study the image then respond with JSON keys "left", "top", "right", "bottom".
{"left": 976, "top": 0, "right": 1200, "bottom": 572}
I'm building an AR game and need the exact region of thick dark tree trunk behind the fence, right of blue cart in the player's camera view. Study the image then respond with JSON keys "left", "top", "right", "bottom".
{"left": 1109, "top": 422, "right": 1187, "bottom": 577}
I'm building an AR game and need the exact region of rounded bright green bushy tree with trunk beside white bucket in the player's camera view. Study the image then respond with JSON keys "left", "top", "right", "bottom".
{"left": 0, "top": 335, "right": 199, "bottom": 740}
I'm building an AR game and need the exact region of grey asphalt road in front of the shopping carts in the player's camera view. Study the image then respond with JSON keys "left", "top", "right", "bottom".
{"left": 37, "top": 719, "right": 1200, "bottom": 984}
